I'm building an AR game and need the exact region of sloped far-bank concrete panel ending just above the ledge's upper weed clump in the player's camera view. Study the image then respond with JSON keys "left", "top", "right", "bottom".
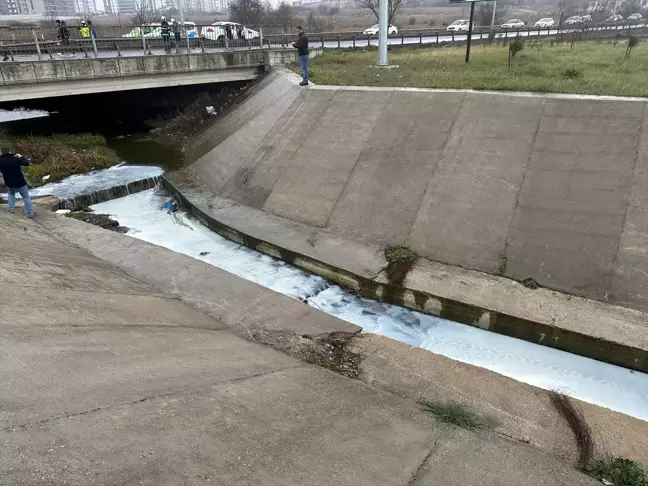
{"left": 329, "top": 92, "right": 464, "bottom": 245}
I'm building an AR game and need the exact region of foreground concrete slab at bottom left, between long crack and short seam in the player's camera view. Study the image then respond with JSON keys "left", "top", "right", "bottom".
{"left": 0, "top": 368, "right": 439, "bottom": 486}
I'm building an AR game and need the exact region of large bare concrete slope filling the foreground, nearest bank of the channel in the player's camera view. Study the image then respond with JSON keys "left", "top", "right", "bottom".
{"left": 0, "top": 208, "right": 596, "bottom": 486}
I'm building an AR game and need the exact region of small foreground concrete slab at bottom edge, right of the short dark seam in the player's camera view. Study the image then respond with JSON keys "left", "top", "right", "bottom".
{"left": 408, "top": 428, "right": 600, "bottom": 486}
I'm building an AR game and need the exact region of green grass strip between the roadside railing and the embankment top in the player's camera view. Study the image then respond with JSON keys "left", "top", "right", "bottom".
{"left": 302, "top": 40, "right": 648, "bottom": 96}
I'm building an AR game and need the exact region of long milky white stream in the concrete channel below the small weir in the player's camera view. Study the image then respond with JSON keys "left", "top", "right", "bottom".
{"left": 93, "top": 190, "right": 648, "bottom": 420}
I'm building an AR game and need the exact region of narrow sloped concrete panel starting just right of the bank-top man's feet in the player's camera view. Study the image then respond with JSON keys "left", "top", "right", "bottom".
{"left": 221, "top": 90, "right": 335, "bottom": 209}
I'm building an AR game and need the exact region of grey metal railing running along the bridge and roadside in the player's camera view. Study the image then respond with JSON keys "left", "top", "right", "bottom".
{"left": 0, "top": 22, "right": 648, "bottom": 61}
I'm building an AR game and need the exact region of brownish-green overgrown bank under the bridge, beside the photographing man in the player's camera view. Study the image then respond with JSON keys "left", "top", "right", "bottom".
{"left": 6, "top": 133, "right": 119, "bottom": 187}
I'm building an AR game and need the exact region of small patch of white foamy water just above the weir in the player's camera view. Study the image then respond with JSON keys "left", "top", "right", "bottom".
{"left": 29, "top": 164, "right": 163, "bottom": 199}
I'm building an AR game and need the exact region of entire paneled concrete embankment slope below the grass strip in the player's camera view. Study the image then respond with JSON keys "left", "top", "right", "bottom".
{"left": 180, "top": 73, "right": 648, "bottom": 309}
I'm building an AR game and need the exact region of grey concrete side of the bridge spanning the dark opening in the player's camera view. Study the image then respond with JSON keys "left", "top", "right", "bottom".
{"left": 0, "top": 48, "right": 296, "bottom": 103}
